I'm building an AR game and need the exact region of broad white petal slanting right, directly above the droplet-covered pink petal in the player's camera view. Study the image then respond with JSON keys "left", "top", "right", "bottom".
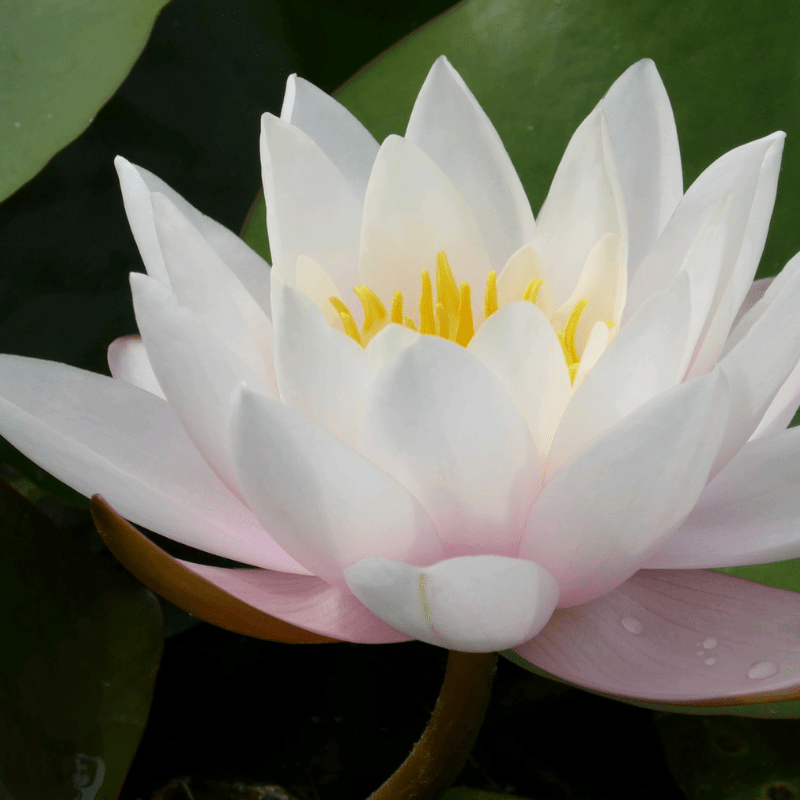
{"left": 519, "top": 370, "right": 727, "bottom": 606}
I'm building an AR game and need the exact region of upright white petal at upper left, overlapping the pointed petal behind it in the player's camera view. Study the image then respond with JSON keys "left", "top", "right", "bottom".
{"left": 261, "top": 114, "right": 362, "bottom": 286}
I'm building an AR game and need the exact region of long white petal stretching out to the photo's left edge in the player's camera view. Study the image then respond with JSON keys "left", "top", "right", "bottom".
{"left": 0, "top": 358, "right": 307, "bottom": 574}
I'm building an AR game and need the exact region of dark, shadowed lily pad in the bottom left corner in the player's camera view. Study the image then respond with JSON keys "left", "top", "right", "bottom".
{"left": 0, "top": 478, "right": 164, "bottom": 800}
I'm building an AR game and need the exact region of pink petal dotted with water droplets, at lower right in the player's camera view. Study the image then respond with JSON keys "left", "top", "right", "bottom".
{"left": 516, "top": 570, "right": 800, "bottom": 706}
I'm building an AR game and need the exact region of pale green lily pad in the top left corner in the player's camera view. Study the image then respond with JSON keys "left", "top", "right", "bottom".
{"left": 0, "top": 0, "right": 167, "bottom": 200}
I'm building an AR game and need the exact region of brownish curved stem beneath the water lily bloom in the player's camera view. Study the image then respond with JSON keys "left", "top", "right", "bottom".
{"left": 369, "top": 650, "right": 497, "bottom": 800}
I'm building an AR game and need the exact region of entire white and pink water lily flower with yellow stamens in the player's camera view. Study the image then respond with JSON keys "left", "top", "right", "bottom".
{"left": 0, "top": 58, "right": 800, "bottom": 702}
